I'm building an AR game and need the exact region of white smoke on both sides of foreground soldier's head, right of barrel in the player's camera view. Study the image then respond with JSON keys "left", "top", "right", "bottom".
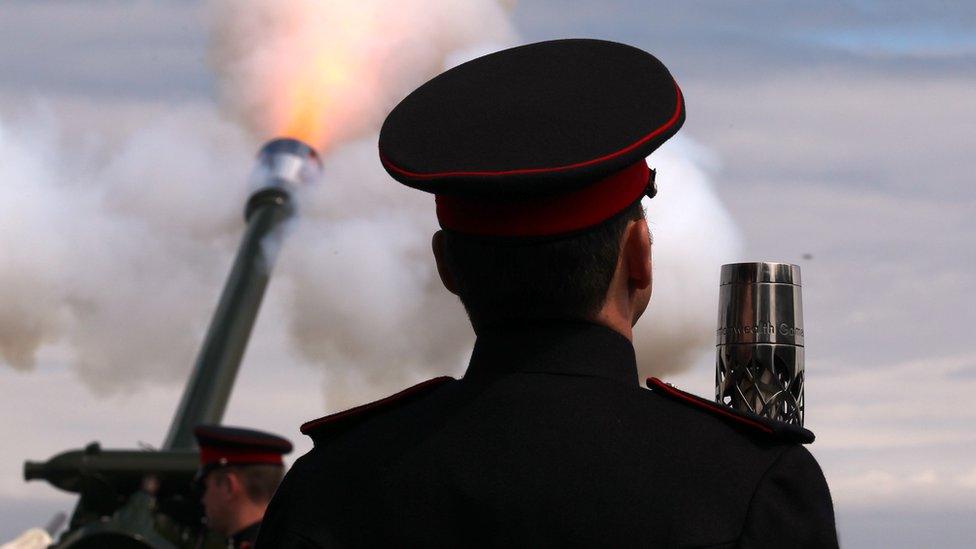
{"left": 279, "top": 135, "right": 740, "bottom": 404}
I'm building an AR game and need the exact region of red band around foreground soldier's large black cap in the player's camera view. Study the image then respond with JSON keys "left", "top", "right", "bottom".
{"left": 435, "top": 158, "right": 650, "bottom": 236}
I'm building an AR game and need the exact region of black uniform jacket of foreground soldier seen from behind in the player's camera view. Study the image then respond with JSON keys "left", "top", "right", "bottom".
{"left": 257, "top": 321, "right": 837, "bottom": 549}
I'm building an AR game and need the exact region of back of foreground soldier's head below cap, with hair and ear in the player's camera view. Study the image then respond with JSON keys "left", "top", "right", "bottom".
{"left": 433, "top": 200, "right": 652, "bottom": 329}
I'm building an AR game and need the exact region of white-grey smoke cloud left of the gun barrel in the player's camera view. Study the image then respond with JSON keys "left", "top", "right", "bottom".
{"left": 0, "top": 105, "right": 255, "bottom": 391}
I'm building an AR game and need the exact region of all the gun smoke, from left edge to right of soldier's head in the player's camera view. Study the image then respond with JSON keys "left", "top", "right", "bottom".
{"left": 0, "top": 0, "right": 738, "bottom": 408}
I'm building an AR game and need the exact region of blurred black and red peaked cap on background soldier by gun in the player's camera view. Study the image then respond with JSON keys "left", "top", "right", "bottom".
{"left": 193, "top": 425, "right": 292, "bottom": 466}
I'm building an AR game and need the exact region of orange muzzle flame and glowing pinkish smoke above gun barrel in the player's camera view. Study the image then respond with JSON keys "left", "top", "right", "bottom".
{"left": 212, "top": 0, "right": 520, "bottom": 153}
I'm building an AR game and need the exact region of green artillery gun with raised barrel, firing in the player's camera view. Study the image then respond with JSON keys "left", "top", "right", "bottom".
{"left": 24, "top": 139, "right": 322, "bottom": 549}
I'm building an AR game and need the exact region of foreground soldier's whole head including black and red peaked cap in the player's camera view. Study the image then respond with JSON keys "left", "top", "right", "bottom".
{"left": 380, "top": 40, "right": 685, "bottom": 332}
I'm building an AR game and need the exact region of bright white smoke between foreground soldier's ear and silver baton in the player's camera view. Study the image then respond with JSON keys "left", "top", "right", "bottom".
{"left": 634, "top": 135, "right": 743, "bottom": 376}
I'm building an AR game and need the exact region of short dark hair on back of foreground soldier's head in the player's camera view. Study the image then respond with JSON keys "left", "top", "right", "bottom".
{"left": 443, "top": 200, "right": 644, "bottom": 329}
